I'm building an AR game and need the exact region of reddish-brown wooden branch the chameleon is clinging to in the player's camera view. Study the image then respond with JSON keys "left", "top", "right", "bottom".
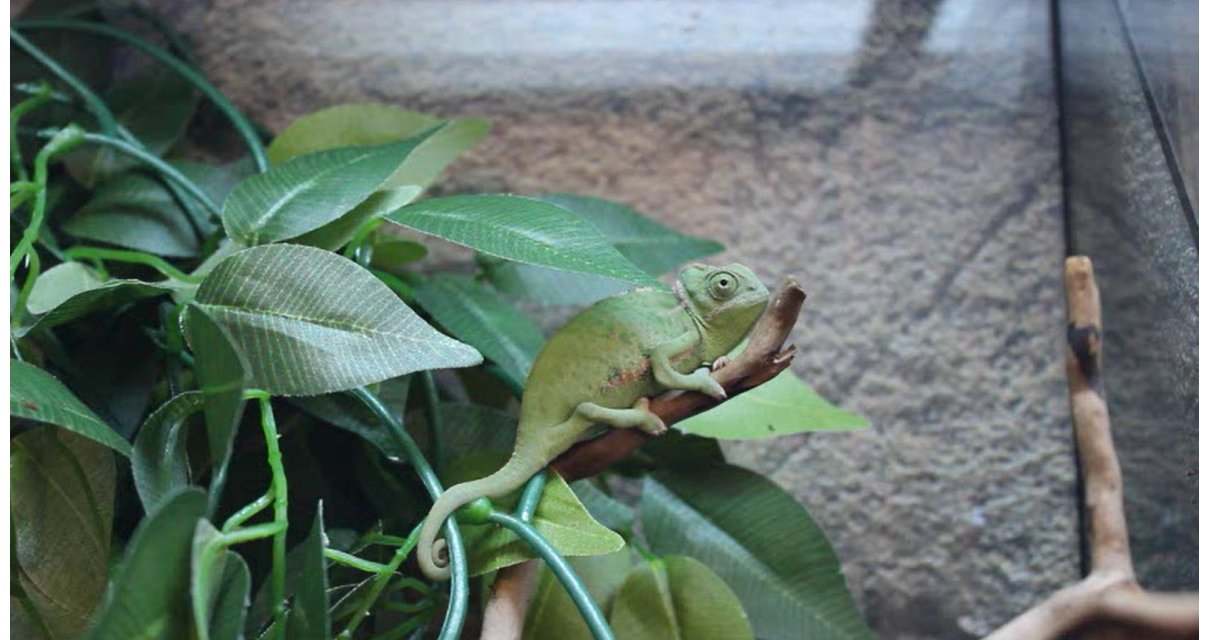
{"left": 480, "top": 278, "right": 807, "bottom": 640}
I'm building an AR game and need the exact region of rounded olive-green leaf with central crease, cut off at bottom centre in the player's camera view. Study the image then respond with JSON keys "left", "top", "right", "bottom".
{"left": 609, "top": 555, "right": 750, "bottom": 640}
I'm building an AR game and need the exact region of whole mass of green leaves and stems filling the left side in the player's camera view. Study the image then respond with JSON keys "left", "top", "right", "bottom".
{"left": 10, "top": 2, "right": 868, "bottom": 640}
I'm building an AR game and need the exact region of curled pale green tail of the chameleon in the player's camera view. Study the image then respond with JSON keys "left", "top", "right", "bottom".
{"left": 416, "top": 455, "right": 547, "bottom": 581}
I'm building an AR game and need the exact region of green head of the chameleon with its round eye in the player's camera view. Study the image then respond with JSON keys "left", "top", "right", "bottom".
{"left": 676, "top": 263, "right": 768, "bottom": 342}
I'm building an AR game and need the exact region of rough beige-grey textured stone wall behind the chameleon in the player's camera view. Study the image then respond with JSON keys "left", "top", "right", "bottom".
{"left": 151, "top": 0, "right": 1078, "bottom": 638}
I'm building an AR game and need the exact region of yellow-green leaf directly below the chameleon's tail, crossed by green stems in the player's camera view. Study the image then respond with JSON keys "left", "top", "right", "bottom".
{"left": 445, "top": 451, "right": 626, "bottom": 576}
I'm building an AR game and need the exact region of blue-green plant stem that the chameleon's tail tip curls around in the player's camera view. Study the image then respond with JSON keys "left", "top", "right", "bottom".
{"left": 348, "top": 387, "right": 471, "bottom": 640}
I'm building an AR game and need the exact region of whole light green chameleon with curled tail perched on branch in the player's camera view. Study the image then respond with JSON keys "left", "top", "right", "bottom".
{"left": 416, "top": 258, "right": 770, "bottom": 581}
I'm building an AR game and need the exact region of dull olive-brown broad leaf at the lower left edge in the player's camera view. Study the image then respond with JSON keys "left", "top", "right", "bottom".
{"left": 8, "top": 427, "right": 115, "bottom": 638}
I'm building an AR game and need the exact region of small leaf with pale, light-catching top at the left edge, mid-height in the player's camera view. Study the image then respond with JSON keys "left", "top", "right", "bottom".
{"left": 13, "top": 263, "right": 175, "bottom": 338}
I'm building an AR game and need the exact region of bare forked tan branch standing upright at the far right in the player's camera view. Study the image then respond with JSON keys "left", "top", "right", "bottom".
{"left": 987, "top": 256, "right": 1198, "bottom": 640}
